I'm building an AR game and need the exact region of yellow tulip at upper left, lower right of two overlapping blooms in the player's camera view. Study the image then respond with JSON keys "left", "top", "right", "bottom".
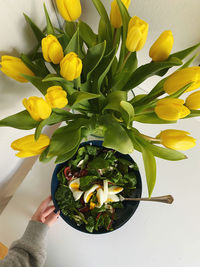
{"left": 60, "top": 52, "right": 82, "bottom": 81}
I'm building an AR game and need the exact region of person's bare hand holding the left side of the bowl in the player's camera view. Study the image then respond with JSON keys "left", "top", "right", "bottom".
{"left": 31, "top": 196, "right": 60, "bottom": 226}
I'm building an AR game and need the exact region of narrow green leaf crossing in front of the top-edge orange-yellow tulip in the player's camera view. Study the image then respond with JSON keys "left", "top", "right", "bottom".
{"left": 117, "top": 0, "right": 131, "bottom": 68}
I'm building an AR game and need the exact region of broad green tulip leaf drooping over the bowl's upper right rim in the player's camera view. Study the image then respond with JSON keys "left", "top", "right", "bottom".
{"left": 100, "top": 115, "right": 133, "bottom": 154}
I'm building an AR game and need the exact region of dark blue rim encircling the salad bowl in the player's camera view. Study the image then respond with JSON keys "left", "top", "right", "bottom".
{"left": 51, "top": 140, "right": 142, "bottom": 234}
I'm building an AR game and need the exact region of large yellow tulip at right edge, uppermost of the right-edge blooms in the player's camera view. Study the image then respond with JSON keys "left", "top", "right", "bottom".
{"left": 163, "top": 66, "right": 200, "bottom": 95}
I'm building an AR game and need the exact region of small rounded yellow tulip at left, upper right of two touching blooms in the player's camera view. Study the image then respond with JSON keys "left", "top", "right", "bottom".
{"left": 45, "top": 86, "right": 68, "bottom": 108}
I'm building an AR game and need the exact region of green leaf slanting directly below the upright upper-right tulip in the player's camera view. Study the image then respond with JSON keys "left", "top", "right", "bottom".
{"left": 111, "top": 52, "right": 138, "bottom": 91}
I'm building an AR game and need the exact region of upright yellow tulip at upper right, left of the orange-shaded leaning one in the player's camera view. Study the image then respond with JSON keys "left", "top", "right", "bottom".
{"left": 126, "top": 16, "right": 149, "bottom": 52}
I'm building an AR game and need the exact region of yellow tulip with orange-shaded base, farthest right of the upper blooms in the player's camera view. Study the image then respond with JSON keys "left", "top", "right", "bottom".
{"left": 149, "top": 31, "right": 174, "bottom": 61}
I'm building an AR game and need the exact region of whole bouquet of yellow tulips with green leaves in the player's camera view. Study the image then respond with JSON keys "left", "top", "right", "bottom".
{"left": 0, "top": 0, "right": 200, "bottom": 196}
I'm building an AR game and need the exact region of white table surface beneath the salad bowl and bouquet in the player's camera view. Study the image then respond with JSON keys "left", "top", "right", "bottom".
{"left": 0, "top": 120, "right": 200, "bottom": 267}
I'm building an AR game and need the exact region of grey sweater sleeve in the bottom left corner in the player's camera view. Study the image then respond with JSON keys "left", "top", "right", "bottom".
{"left": 0, "top": 221, "right": 49, "bottom": 267}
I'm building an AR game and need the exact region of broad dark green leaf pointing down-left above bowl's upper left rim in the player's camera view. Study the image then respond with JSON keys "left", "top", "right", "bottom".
{"left": 47, "top": 119, "right": 88, "bottom": 157}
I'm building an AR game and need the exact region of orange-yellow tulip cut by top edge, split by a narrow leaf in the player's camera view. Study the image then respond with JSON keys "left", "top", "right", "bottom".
{"left": 110, "top": 0, "right": 131, "bottom": 28}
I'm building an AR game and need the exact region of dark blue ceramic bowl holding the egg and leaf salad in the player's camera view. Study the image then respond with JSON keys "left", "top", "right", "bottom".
{"left": 51, "top": 140, "right": 142, "bottom": 234}
